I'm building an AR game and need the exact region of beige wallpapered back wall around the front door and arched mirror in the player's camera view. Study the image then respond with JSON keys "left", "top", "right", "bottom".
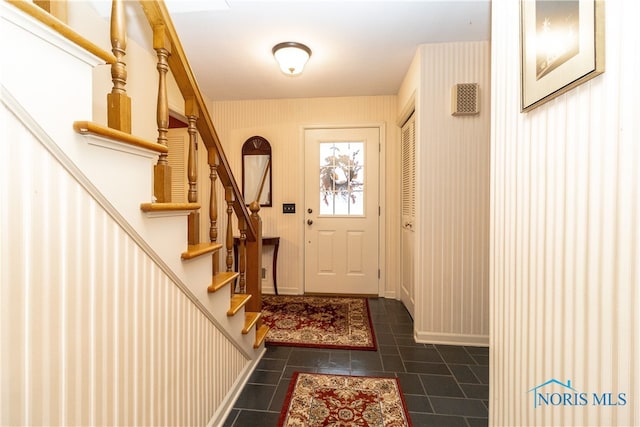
{"left": 200, "top": 96, "right": 400, "bottom": 296}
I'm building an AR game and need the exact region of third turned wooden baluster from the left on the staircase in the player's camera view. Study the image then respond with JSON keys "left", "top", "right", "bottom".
{"left": 184, "top": 96, "right": 200, "bottom": 245}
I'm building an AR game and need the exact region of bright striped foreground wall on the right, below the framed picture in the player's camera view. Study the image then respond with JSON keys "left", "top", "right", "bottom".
{"left": 489, "top": 0, "right": 640, "bottom": 426}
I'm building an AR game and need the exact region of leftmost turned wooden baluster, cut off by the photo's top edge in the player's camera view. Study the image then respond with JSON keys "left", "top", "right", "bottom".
{"left": 107, "top": 0, "right": 131, "bottom": 133}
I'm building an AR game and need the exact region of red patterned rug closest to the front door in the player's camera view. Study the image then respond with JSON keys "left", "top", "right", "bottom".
{"left": 262, "top": 295, "right": 376, "bottom": 350}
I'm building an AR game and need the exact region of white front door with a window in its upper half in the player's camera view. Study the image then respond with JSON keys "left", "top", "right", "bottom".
{"left": 304, "top": 127, "right": 380, "bottom": 295}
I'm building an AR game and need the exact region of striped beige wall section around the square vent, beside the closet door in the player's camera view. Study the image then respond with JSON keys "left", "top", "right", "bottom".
{"left": 414, "top": 42, "right": 490, "bottom": 345}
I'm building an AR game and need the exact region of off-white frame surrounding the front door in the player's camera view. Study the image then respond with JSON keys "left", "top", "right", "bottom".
{"left": 298, "top": 122, "right": 387, "bottom": 297}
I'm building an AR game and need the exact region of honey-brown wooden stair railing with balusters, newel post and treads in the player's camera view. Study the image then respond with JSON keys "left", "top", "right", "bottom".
{"left": 8, "top": 0, "right": 268, "bottom": 348}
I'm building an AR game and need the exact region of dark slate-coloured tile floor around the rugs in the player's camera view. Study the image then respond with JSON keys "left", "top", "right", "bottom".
{"left": 224, "top": 298, "right": 489, "bottom": 427}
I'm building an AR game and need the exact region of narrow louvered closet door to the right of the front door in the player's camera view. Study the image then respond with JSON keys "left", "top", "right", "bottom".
{"left": 400, "top": 114, "right": 416, "bottom": 317}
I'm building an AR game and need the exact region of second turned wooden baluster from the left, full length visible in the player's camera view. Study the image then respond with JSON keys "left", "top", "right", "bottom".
{"left": 153, "top": 25, "right": 171, "bottom": 203}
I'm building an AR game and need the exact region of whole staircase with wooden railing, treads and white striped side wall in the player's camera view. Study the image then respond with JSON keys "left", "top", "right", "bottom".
{"left": 0, "top": 1, "right": 268, "bottom": 425}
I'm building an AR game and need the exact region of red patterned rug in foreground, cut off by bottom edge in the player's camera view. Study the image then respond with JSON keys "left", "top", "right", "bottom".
{"left": 278, "top": 372, "right": 412, "bottom": 427}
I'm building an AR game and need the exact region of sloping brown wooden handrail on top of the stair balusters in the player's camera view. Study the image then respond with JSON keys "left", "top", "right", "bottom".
{"left": 140, "top": 0, "right": 258, "bottom": 241}
